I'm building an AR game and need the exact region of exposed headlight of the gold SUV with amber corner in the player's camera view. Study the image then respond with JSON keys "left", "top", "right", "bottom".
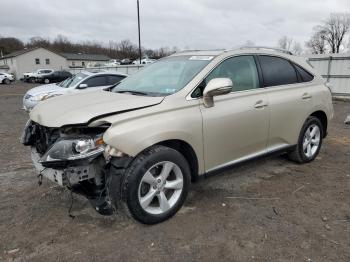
{"left": 39, "top": 136, "right": 105, "bottom": 163}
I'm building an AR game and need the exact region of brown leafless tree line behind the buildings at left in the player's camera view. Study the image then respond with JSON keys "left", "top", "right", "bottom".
{"left": 0, "top": 35, "right": 178, "bottom": 59}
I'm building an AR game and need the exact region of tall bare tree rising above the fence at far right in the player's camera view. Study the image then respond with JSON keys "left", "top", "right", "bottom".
{"left": 318, "top": 13, "right": 350, "bottom": 53}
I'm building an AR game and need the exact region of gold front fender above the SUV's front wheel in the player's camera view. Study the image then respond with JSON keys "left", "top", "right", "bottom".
{"left": 103, "top": 102, "right": 204, "bottom": 172}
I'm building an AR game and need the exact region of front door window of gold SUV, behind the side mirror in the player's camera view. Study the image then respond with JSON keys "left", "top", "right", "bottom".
{"left": 192, "top": 55, "right": 259, "bottom": 97}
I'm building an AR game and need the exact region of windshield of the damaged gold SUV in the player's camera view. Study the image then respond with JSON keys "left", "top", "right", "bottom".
{"left": 112, "top": 56, "right": 213, "bottom": 96}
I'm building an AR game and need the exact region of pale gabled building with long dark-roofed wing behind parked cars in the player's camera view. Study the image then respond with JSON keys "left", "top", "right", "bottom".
{"left": 0, "top": 47, "right": 110, "bottom": 79}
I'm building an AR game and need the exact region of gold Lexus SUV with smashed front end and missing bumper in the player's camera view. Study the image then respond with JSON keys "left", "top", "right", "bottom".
{"left": 22, "top": 48, "right": 333, "bottom": 224}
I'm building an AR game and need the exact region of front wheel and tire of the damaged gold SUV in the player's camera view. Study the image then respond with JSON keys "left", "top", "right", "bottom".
{"left": 121, "top": 146, "right": 191, "bottom": 224}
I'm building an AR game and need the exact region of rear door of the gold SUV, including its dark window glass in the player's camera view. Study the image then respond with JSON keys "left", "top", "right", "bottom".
{"left": 258, "top": 55, "right": 313, "bottom": 151}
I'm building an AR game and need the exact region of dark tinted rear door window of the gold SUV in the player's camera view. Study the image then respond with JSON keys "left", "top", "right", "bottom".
{"left": 259, "top": 55, "right": 298, "bottom": 87}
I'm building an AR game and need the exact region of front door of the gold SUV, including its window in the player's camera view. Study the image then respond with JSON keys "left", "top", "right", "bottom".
{"left": 200, "top": 55, "right": 269, "bottom": 172}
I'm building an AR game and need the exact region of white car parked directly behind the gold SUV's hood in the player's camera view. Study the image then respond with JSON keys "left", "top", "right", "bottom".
{"left": 23, "top": 71, "right": 127, "bottom": 112}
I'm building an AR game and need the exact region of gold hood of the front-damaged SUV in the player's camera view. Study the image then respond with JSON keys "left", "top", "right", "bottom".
{"left": 29, "top": 90, "right": 164, "bottom": 127}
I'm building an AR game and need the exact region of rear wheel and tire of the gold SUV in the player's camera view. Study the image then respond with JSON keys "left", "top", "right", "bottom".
{"left": 289, "top": 116, "right": 324, "bottom": 164}
